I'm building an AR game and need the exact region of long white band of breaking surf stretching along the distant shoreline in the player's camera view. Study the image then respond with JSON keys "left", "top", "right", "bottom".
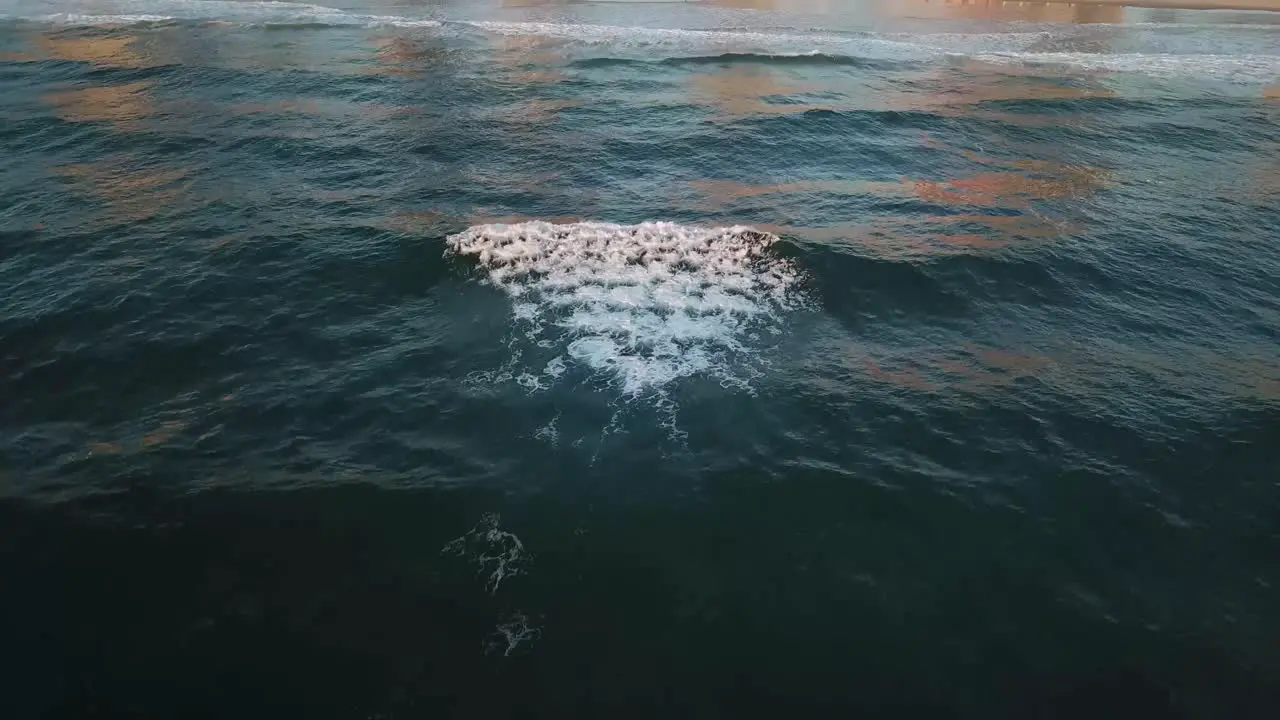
{"left": 7, "top": 6, "right": 1280, "bottom": 85}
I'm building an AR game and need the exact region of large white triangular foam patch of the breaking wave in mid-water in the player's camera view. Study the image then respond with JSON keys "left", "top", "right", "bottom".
{"left": 448, "top": 222, "right": 804, "bottom": 398}
